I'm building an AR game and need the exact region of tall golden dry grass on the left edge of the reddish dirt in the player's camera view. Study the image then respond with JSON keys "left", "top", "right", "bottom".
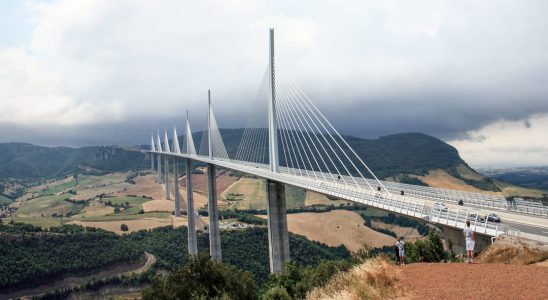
{"left": 307, "top": 257, "right": 403, "bottom": 300}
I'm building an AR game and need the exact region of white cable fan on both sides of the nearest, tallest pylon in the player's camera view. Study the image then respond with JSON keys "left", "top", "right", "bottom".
{"left": 235, "top": 63, "right": 386, "bottom": 190}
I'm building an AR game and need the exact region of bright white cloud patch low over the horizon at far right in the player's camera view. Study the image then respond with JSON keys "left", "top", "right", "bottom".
{"left": 449, "top": 114, "right": 548, "bottom": 167}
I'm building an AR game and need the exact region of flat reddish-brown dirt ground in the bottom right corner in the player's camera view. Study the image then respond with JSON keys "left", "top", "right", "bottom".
{"left": 398, "top": 263, "right": 548, "bottom": 299}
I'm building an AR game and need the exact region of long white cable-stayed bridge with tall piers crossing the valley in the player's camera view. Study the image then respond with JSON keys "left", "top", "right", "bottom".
{"left": 149, "top": 29, "right": 548, "bottom": 273}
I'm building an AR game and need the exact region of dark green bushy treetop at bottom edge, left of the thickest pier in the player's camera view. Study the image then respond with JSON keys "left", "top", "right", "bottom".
{"left": 143, "top": 253, "right": 257, "bottom": 299}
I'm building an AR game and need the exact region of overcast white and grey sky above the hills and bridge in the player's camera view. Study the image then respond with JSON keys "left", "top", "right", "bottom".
{"left": 0, "top": 0, "right": 548, "bottom": 168}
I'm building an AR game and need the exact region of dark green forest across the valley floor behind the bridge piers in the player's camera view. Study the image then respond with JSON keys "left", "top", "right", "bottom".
{"left": 0, "top": 223, "right": 350, "bottom": 291}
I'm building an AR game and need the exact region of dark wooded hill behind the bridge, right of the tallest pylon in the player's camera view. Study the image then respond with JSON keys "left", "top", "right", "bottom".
{"left": 200, "top": 129, "right": 500, "bottom": 192}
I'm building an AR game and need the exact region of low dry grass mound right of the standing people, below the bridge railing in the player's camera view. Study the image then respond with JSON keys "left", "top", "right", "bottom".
{"left": 478, "top": 238, "right": 548, "bottom": 265}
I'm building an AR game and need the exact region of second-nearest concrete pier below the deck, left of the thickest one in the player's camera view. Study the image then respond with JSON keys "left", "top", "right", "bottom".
{"left": 207, "top": 164, "right": 222, "bottom": 261}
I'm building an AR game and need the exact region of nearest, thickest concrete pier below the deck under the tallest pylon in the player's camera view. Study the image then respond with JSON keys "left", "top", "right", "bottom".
{"left": 266, "top": 180, "right": 290, "bottom": 274}
